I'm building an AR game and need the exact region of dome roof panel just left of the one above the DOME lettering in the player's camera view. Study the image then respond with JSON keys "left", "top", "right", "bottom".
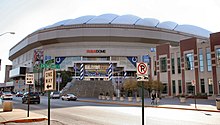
{"left": 64, "top": 15, "right": 95, "bottom": 25}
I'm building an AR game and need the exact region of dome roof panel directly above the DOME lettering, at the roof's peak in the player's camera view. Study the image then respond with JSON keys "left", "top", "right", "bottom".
{"left": 86, "top": 14, "right": 118, "bottom": 24}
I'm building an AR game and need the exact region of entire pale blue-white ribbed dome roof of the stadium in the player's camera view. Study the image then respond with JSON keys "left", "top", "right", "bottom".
{"left": 39, "top": 14, "right": 211, "bottom": 37}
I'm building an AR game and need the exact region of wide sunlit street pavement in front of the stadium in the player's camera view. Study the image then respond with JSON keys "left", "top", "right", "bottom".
{"left": 13, "top": 96, "right": 220, "bottom": 125}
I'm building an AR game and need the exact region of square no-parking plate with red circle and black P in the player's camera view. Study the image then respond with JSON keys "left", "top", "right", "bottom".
{"left": 137, "top": 62, "right": 148, "bottom": 76}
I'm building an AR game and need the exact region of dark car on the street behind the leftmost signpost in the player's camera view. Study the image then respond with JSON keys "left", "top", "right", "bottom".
{"left": 22, "top": 92, "right": 40, "bottom": 104}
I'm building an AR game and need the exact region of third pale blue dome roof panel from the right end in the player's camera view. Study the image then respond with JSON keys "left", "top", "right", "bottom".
{"left": 135, "top": 18, "right": 160, "bottom": 27}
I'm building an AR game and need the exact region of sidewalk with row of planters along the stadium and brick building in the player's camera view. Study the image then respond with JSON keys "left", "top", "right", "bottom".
{"left": 79, "top": 98, "right": 220, "bottom": 112}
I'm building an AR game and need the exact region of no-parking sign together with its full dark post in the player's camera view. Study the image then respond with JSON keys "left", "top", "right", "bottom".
{"left": 136, "top": 62, "right": 148, "bottom": 125}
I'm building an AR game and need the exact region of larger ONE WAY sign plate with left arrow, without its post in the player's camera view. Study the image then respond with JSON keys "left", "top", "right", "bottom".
{"left": 44, "top": 70, "right": 56, "bottom": 91}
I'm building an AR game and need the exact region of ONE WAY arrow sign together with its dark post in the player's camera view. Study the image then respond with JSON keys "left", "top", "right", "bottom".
{"left": 44, "top": 70, "right": 56, "bottom": 125}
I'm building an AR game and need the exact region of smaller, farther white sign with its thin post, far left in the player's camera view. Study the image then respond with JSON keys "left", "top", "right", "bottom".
{"left": 25, "top": 73, "right": 34, "bottom": 117}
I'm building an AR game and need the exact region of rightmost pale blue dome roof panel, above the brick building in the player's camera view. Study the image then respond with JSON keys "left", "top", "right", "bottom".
{"left": 174, "top": 25, "right": 211, "bottom": 37}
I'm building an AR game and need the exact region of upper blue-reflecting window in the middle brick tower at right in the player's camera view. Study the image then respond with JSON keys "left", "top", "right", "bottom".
{"left": 185, "top": 53, "right": 194, "bottom": 70}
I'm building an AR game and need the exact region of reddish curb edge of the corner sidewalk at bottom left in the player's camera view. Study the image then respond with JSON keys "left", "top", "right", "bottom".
{"left": 0, "top": 118, "right": 48, "bottom": 124}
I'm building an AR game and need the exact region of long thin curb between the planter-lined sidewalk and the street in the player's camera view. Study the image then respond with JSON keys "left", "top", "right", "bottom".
{"left": 78, "top": 100, "right": 220, "bottom": 113}
